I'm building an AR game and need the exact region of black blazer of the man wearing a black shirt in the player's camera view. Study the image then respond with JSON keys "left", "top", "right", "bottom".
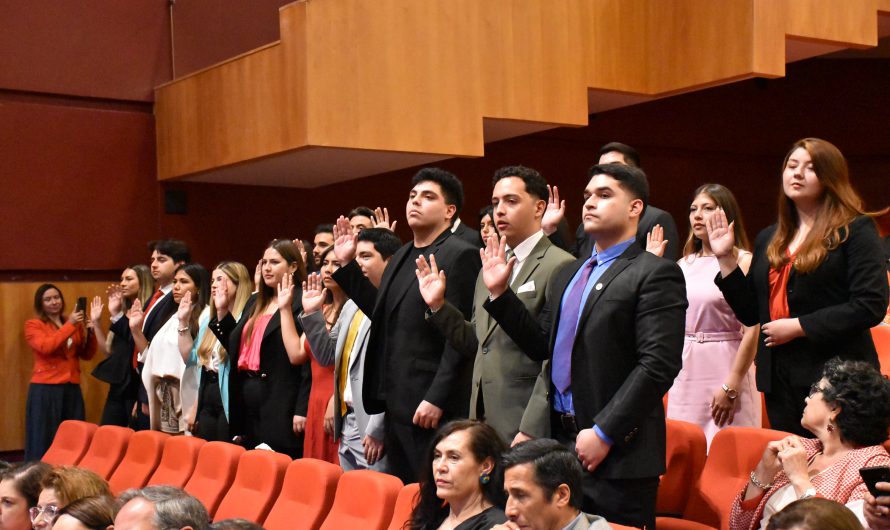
{"left": 333, "top": 230, "right": 482, "bottom": 425}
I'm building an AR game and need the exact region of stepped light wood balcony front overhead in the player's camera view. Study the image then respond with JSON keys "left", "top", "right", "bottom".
{"left": 156, "top": 0, "right": 890, "bottom": 185}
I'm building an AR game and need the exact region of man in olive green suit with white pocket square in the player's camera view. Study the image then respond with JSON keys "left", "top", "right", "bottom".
{"left": 418, "top": 166, "right": 573, "bottom": 443}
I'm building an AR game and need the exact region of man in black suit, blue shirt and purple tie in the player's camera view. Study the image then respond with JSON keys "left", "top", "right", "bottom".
{"left": 484, "top": 164, "right": 687, "bottom": 527}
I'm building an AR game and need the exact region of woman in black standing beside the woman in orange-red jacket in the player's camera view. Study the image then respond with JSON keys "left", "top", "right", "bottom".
{"left": 90, "top": 264, "right": 154, "bottom": 427}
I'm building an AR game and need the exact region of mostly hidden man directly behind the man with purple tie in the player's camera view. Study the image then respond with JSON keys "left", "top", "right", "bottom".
{"left": 543, "top": 142, "right": 681, "bottom": 261}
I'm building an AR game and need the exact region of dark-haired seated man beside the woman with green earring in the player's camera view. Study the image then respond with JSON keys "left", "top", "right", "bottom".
{"left": 492, "top": 438, "right": 611, "bottom": 530}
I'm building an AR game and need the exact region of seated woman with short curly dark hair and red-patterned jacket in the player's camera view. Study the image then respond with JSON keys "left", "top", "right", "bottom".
{"left": 729, "top": 359, "right": 890, "bottom": 530}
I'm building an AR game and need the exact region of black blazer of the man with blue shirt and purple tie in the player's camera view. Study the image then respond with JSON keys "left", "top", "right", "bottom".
{"left": 485, "top": 245, "right": 687, "bottom": 479}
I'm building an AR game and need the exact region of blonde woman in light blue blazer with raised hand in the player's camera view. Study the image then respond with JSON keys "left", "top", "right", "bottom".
{"left": 179, "top": 261, "right": 253, "bottom": 442}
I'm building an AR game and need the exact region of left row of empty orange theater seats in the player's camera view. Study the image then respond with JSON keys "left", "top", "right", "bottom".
{"left": 43, "top": 421, "right": 417, "bottom": 530}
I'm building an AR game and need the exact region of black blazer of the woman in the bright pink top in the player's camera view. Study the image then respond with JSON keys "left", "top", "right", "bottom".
{"left": 208, "top": 289, "right": 312, "bottom": 455}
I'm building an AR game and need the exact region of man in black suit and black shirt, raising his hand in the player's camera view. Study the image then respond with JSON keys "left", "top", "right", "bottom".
{"left": 333, "top": 168, "right": 481, "bottom": 484}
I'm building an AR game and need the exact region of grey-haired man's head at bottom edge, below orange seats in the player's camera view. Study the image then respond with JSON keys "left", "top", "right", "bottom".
{"left": 114, "top": 486, "right": 210, "bottom": 530}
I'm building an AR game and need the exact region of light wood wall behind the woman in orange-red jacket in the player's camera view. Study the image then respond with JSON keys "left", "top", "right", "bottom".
{"left": 0, "top": 279, "right": 111, "bottom": 451}
